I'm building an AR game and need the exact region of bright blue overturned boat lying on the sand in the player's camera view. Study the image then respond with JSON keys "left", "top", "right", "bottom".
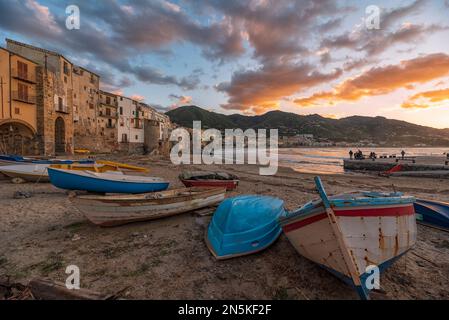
{"left": 206, "top": 195, "right": 285, "bottom": 259}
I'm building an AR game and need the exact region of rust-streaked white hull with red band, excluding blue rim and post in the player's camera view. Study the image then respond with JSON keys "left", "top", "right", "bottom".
{"left": 282, "top": 204, "right": 416, "bottom": 279}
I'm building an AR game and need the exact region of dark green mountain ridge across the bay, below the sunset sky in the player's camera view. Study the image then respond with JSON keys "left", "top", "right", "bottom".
{"left": 166, "top": 105, "right": 449, "bottom": 147}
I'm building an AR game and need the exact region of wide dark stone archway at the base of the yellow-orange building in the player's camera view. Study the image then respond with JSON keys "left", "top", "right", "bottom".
{"left": 0, "top": 120, "right": 37, "bottom": 155}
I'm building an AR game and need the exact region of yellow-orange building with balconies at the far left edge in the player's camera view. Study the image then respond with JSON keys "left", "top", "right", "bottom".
{"left": 0, "top": 48, "right": 38, "bottom": 155}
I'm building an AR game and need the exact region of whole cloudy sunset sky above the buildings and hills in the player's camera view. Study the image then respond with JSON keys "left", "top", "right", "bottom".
{"left": 0, "top": 0, "right": 449, "bottom": 128}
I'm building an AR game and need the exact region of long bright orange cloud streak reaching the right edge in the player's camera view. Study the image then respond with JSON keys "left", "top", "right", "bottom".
{"left": 294, "top": 53, "right": 449, "bottom": 107}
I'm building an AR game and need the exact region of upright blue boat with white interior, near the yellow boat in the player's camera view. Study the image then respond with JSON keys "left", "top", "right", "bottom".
{"left": 48, "top": 167, "right": 169, "bottom": 193}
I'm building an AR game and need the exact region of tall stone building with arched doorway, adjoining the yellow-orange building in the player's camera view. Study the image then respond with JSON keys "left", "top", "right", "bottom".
{"left": 6, "top": 39, "right": 74, "bottom": 155}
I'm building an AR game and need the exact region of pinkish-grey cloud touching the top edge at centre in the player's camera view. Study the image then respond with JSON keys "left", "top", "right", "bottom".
{"left": 192, "top": 0, "right": 350, "bottom": 62}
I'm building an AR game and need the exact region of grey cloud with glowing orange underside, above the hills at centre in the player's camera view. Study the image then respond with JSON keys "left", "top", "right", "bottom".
{"left": 217, "top": 64, "right": 341, "bottom": 113}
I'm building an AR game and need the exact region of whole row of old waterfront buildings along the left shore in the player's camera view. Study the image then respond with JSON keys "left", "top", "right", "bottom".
{"left": 0, "top": 39, "right": 172, "bottom": 155}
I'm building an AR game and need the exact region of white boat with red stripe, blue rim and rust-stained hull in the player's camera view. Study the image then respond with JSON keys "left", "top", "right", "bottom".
{"left": 280, "top": 179, "right": 416, "bottom": 298}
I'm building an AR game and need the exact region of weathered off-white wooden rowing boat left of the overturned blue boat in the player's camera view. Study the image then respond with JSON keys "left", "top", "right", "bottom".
{"left": 71, "top": 188, "right": 226, "bottom": 226}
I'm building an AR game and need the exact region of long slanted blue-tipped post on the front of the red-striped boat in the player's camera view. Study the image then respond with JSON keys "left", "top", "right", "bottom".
{"left": 315, "top": 177, "right": 369, "bottom": 300}
